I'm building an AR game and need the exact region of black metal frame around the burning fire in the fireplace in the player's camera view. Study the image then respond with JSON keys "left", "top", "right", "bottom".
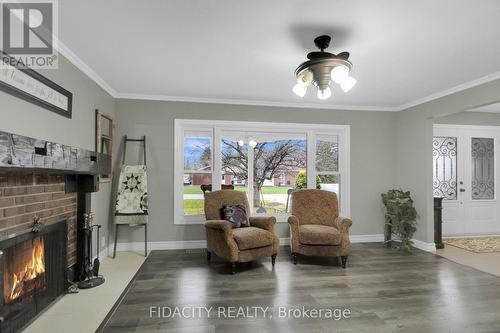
{"left": 0, "top": 219, "right": 68, "bottom": 333}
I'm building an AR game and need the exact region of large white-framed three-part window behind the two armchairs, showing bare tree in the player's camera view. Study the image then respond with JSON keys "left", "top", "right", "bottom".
{"left": 174, "top": 120, "right": 349, "bottom": 224}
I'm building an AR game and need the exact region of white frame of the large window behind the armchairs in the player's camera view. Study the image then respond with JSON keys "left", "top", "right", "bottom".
{"left": 174, "top": 119, "right": 351, "bottom": 224}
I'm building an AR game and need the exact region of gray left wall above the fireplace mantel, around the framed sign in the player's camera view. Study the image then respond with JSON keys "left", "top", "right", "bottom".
{"left": 0, "top": 56, "right": 115, "bottom": 254}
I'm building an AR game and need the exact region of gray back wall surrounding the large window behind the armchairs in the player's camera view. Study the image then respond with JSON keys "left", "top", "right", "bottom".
{"left": 115, "top": 100, "right": 396, "bottom": 243}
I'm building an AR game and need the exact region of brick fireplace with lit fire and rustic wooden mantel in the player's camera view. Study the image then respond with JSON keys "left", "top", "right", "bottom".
{"left": 0, "top": 132, "right": 111, "bottom": 332}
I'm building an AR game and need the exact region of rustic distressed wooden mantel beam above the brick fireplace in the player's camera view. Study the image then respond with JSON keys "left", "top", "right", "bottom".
{"left": 0, "top": 131, "right": 111, "bottom": 175}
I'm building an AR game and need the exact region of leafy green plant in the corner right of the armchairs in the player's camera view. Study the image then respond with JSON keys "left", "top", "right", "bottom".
{"left": 382, "top": 190, "right": 417, "bottom": 251}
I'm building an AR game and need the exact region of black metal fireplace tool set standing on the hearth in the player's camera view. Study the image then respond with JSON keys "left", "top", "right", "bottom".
{"left": 78, "top": 212, "right": 105, "bottom": 289}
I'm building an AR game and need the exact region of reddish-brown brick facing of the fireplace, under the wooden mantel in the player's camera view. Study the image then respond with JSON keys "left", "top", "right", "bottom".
{"left": 0, "top": 172, "right": 77, "bottom": 267}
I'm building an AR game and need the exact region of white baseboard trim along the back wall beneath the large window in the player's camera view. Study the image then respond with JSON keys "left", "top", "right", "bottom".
{"left": 111, "top": 234, "right": 384, "bottom": 255}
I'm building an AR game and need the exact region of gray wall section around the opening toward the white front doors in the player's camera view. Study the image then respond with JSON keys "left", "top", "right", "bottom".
{"left": 396, "top": 80, "right": 500, "bottom": 243}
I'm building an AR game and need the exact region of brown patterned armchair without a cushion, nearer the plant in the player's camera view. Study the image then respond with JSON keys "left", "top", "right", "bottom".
{"left": 288, "top": 190, "right": 352, "bottom": 268}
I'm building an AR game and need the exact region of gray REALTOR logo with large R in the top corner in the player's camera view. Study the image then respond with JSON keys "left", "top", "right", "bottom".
{"left": 0, "top": 0, "right": 57, "bottom": 69}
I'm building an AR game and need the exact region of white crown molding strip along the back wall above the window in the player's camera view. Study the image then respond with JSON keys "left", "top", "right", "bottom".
{"left": 116, "top": 93, "right": 399, "bottom": 112}
